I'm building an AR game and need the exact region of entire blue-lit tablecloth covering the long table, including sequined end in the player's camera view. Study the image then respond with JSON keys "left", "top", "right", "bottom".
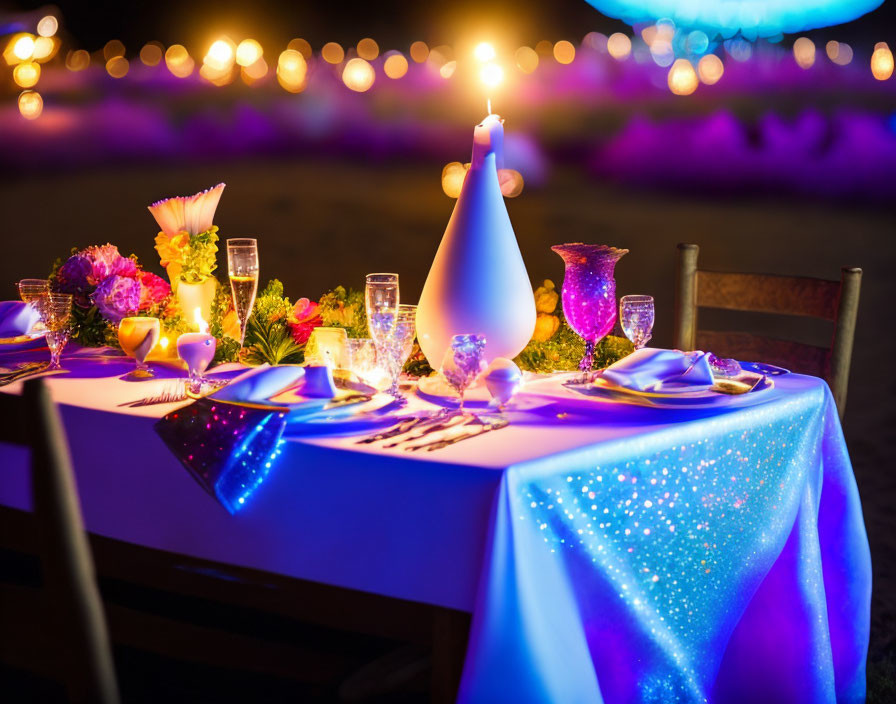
{"left": 0, "top": 346, "right": 871, "bottom": 704}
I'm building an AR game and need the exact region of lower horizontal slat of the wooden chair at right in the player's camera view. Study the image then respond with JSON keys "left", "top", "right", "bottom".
{"left": 697, "top": 330, "right": 830, "bottom": 377}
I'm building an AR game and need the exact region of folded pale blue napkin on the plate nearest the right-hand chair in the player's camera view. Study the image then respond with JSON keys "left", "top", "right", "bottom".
{"left": 601, "top": 347, "right": 713, "bottom": 391}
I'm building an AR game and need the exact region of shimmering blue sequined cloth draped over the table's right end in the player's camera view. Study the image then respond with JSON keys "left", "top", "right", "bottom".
{"left": 459, "top": 377, "right": 871, "bottom": 704}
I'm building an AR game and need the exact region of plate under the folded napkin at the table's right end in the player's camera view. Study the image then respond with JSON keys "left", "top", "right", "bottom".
{"left": 564, "top": 375, "right": 775, "bottom": 409}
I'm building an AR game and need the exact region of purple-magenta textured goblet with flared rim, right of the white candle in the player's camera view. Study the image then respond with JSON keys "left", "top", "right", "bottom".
{"left": 551, "top": 242, "right": 628, "bottom": 382}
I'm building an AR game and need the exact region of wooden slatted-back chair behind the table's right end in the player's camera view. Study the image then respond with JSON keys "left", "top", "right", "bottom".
{"left": 675, "top": 244, "right": 862, "bottom": 418}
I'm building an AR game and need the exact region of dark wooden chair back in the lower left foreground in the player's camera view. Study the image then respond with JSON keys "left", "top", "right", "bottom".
{"left": 0, "top": 379, "right": 119, "bottom": 704}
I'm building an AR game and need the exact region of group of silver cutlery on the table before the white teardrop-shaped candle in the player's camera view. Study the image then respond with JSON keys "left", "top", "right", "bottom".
{"left": 357, "top": 409, "right": 509, "bottom": 452}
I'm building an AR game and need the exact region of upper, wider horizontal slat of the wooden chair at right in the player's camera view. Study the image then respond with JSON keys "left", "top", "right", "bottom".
{"left": 697, "top": 270, "right": 840, "bottom": 320}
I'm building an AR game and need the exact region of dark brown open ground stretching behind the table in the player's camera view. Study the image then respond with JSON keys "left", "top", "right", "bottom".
{"left": 0, "top": 161, "right": 896, "bottom": 672}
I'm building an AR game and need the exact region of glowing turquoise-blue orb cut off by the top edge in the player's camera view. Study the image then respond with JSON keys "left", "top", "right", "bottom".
{"left": 586, "top": 0, "right": 883, "bottom": 41}
